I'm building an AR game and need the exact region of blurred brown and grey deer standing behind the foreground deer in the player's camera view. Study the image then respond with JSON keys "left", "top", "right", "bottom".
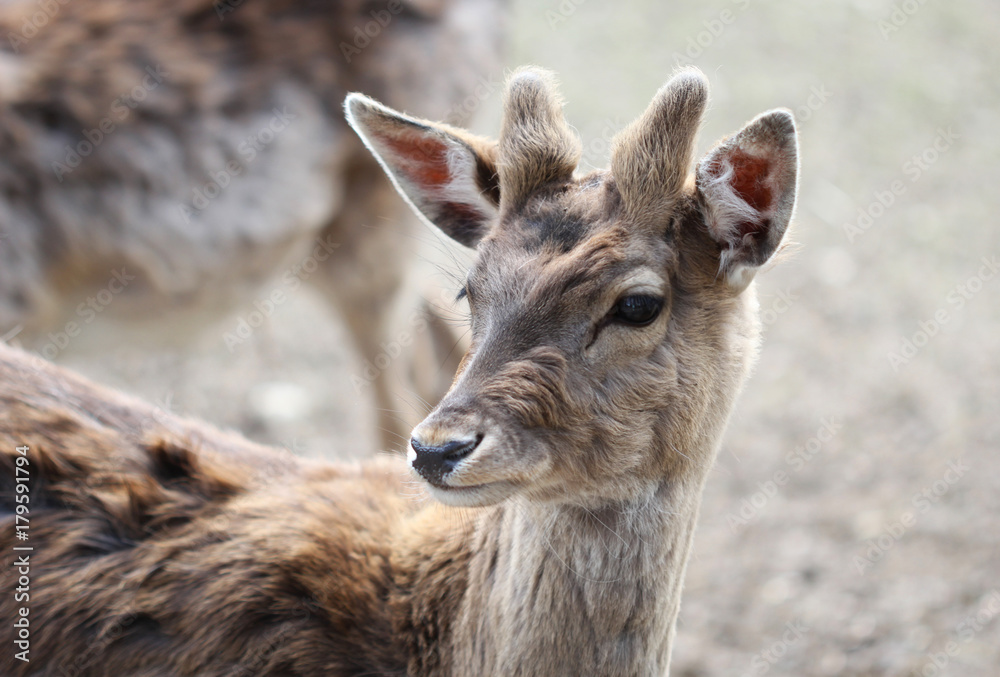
{"left": 0, "top": 0, "right": 505, "bottom": 446}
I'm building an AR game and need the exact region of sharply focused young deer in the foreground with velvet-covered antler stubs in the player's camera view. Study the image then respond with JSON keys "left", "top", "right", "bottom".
{"left": 0, "top": 64, "right": 797, "bottom": 677}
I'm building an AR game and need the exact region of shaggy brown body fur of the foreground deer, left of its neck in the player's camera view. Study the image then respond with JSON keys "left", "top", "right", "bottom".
{"left": 0, "top": 348, "right": 429, "bottom": 677}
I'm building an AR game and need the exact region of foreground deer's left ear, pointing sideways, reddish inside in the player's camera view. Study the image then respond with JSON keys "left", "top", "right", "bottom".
{"left": 344, "top": 94, "right": 500, "bottom": 247}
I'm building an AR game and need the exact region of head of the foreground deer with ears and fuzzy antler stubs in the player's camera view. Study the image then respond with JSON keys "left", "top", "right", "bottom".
{"left": 347, "top": 70, "right": 797, "bottom": 505}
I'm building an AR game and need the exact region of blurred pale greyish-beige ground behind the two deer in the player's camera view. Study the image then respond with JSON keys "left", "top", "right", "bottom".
{"left": 50, "top": 0, "right": 1000, "bottom": 677}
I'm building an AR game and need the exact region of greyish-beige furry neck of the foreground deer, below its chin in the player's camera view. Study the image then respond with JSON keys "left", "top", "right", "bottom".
{"left": 453, "top": 470, "right": 703, "bottom": 676}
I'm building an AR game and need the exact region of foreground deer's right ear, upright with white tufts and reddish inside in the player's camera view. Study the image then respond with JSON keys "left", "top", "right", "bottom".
{"left": 696, "top": 110, "right": 799, "bottom": 290}
